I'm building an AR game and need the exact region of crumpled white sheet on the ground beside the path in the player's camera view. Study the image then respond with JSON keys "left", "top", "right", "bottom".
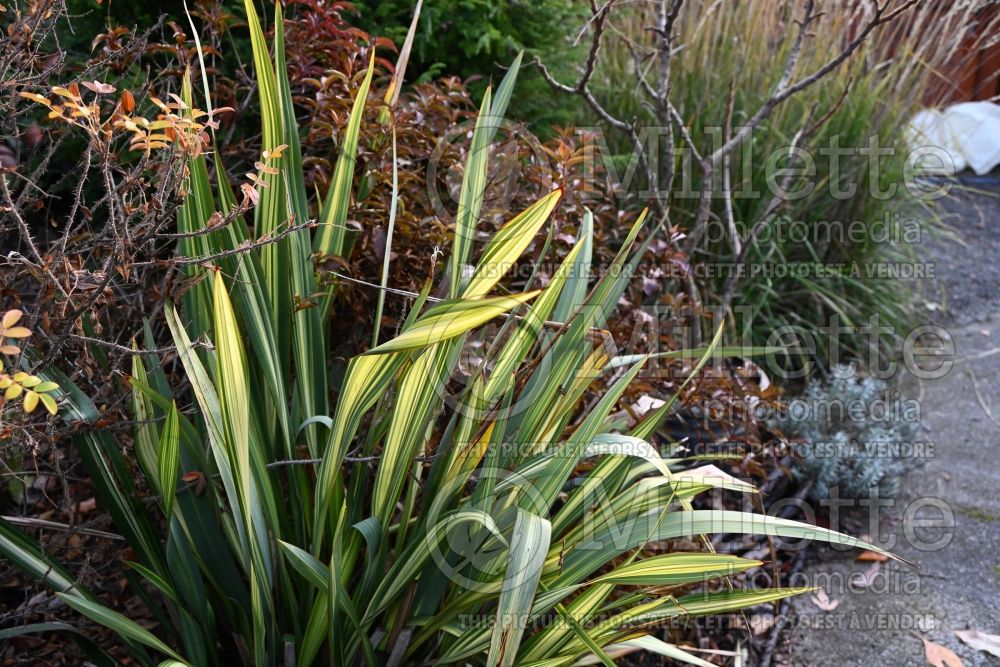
{"left": 908, "top": 102, "right": 1000, "bottom": 176}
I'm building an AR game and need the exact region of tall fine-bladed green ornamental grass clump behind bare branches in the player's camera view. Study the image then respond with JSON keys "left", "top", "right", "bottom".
{"left": 542, "top": 0, "right": 1000, "bottom": 360}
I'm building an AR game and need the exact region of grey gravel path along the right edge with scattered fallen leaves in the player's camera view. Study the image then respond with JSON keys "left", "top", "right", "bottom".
{"left": 775, "top": 176, "right": 1000, "bottom": 667}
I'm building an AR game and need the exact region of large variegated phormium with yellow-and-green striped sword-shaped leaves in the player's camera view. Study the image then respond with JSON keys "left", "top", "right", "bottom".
{"left": 0, "top": 0, "right": 896, "bottom": 667}
